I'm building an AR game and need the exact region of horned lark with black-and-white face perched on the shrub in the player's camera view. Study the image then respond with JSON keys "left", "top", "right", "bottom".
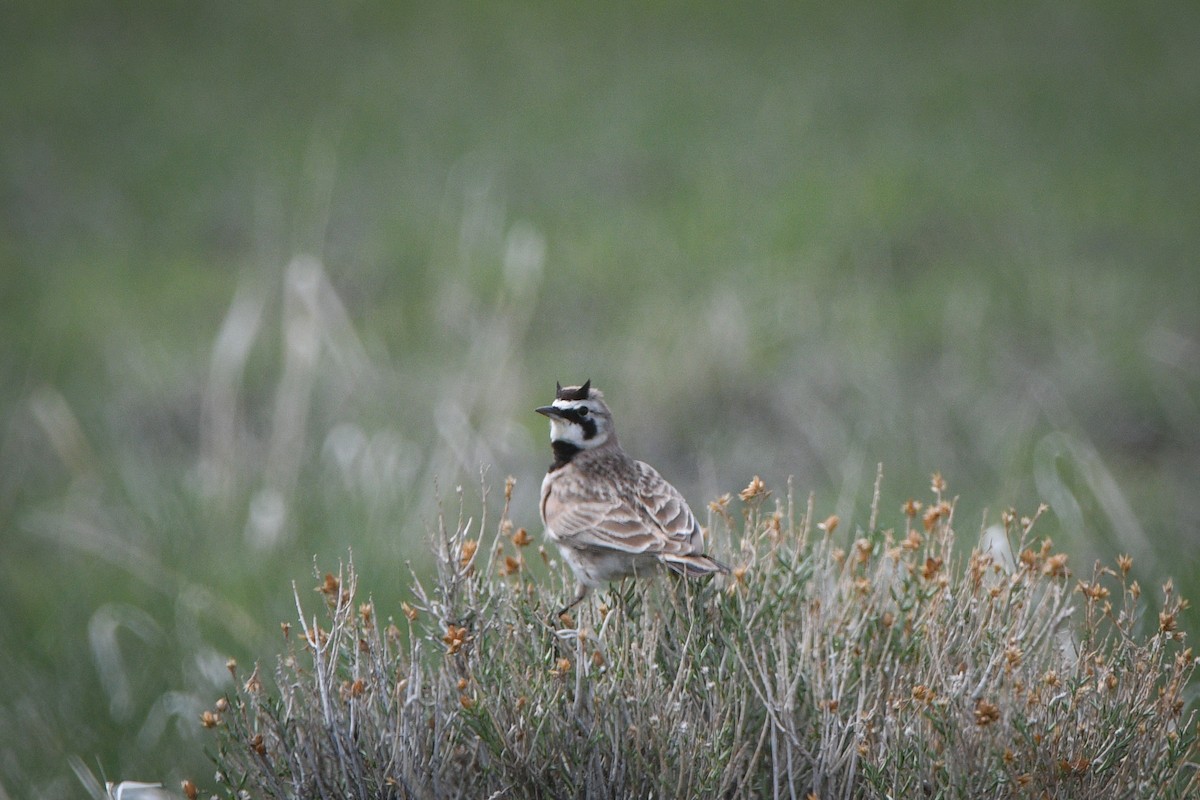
{"left": 536, "top": 380, "right": 728, "bottom": 612}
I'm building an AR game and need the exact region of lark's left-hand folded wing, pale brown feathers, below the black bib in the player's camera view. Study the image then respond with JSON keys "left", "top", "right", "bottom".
{"left": 541, "top": 472, "right": 665, "bottom": 553}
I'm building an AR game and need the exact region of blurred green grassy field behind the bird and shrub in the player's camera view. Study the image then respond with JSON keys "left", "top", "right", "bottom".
{"left": 0, "top": 1, "right": 1200, "bottom": 798}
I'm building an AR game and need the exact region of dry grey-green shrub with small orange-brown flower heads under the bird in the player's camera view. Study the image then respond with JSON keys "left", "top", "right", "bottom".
{"left": 204, "top": 476, "right": 1200, "bottom": 800}
